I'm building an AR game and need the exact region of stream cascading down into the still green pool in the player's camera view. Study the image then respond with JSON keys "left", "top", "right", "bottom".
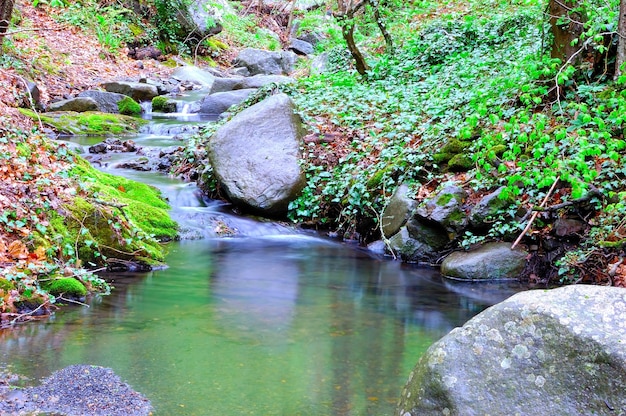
{"left": 0, "top": 92, "right": 520, "bottom": 416}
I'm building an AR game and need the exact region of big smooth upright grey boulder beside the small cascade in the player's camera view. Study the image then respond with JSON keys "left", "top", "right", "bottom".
{"left": 208, "top": 94, "right": 305, "bottom": 215}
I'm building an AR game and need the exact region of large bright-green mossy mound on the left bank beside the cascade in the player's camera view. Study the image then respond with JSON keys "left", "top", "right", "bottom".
{"left": 49, "top": 158, "right": 178, "bottom": 266}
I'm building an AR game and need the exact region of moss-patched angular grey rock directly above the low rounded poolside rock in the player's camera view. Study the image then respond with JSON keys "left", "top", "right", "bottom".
{"left": 414, "top": 183, "right": 468, "bottom": 237}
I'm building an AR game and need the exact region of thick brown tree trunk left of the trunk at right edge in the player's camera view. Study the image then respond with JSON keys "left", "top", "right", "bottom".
{"left": 549, "top": 0, "right": 586, "bottom": 65}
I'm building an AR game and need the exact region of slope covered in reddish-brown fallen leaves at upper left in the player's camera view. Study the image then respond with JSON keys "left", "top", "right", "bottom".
{"left": 0, "top": 1, "right": 171, "bottom": 129}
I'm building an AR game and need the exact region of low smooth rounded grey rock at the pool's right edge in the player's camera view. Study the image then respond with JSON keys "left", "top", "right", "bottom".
{"left": 441, "top": 243, "right": 528, "bottom": 281}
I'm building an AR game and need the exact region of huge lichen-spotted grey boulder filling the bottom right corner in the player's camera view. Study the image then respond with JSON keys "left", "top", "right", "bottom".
{"left": 396, "top": 286, "right": 626, "bottom": 416}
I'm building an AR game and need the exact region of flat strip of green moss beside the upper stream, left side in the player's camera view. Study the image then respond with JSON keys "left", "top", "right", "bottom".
{"left": 19, "top": 108, "right": 147, "bottom": 135}
